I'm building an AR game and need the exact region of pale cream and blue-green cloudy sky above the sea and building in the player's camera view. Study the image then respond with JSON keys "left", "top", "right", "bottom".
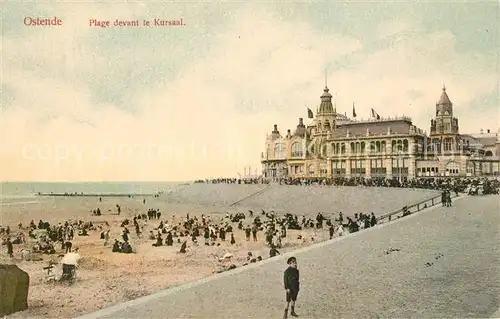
{"left": 0, "top": 0, "right": 500, "bottom": 181}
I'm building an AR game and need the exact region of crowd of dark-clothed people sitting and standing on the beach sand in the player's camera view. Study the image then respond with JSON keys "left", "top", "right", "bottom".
{"left": 0, "top": 201, "right": 384, "bottom": 278}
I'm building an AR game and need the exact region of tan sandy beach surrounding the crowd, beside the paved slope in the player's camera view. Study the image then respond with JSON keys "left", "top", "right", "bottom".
{"left": 0, "top": 190, "right": 336, "bottom": 318}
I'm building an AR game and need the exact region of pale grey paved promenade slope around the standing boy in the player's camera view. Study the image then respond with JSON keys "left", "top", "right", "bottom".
{"left": 82, "top": 196, "right": 500, "bottom": 318}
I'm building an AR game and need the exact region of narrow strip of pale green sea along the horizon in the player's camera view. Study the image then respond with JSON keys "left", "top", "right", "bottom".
{"left": 0, "top": 182, "right": 184, "bottom": 203}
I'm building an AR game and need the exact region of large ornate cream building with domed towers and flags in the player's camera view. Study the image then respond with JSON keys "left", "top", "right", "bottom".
{"left": 261, "top": 87, "right": 500, "bottom": 181}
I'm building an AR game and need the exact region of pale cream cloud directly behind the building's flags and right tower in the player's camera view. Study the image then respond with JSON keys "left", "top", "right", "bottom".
{"left": 324, "top": 31, "right": 498, "bottom": 130}
